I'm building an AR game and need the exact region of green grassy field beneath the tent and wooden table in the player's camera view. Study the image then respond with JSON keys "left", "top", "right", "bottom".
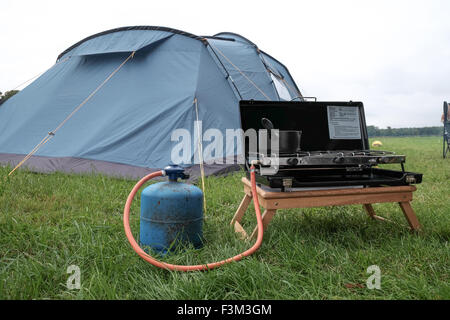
{"left": 0, "top": 137, "right": 450, "bottom": 299}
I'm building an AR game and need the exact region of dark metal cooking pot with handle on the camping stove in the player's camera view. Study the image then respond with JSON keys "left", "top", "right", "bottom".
{"left": 261, "top": 118, "right": 302, "bottom": 154}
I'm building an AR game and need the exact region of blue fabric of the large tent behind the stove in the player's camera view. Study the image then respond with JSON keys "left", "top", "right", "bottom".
{"left": 0, "top": 27, "right": 298, "bottom": 178}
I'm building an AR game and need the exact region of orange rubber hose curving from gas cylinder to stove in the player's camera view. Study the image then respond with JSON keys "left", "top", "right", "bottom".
{"left": 123, "top": 166, "right": 264, "bottom": 271}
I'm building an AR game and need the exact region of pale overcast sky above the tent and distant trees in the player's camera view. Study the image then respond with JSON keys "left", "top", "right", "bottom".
{"left": 0, "top": 0, "right": 450, "bottom": 128}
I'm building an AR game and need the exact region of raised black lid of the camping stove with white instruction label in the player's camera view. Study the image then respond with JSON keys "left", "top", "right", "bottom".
{"left": 239, "top": 100, "right": 370, "bottom": 158}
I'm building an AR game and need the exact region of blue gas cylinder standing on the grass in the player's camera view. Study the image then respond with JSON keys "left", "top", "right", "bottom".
{"left": 140, "top": 166, "right": 203, "bottom": 252}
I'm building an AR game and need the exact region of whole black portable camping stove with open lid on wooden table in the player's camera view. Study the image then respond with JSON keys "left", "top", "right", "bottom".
{"left": 240, "top": 100, "right": 422, "bottom": 191}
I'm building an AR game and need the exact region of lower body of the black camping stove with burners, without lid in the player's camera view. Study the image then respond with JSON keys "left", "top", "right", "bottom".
{"left": 249, "top": 150, "right": 422, "bottom": 191}
